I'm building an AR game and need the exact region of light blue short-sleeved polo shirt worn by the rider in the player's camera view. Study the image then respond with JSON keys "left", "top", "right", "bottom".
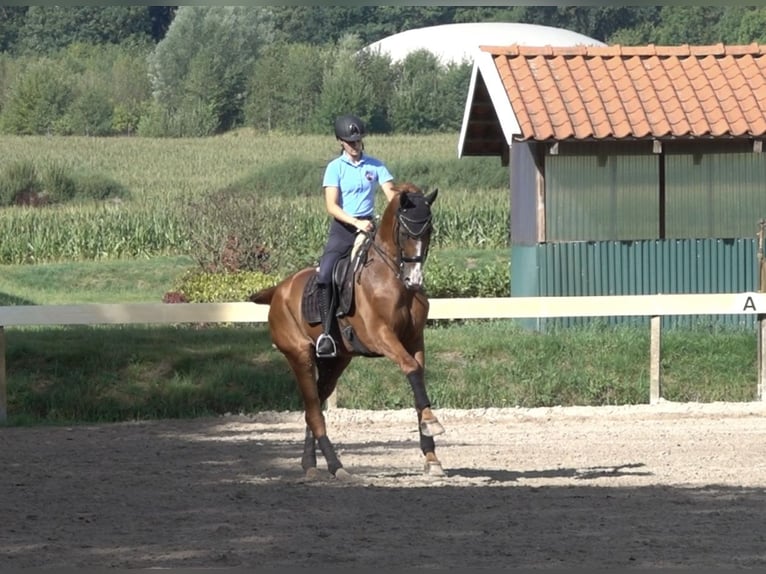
{"left": 322, "top": 153, "right": 394, "bottom": 217}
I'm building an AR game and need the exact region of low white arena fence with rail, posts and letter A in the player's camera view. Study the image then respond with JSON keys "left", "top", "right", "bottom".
{"left": 0, "top": 293, "right": 766, "bottom": 422}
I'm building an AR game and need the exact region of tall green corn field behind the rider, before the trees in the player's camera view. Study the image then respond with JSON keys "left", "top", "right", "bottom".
{"left": 0, "top": 133, "right": 510, "bottom": 264}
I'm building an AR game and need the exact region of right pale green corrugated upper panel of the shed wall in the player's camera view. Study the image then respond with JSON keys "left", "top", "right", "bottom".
{"left": 665, "top": 151, "right": 766, "bottom": 238}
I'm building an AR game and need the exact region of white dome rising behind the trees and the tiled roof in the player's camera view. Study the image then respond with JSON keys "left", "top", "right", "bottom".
{"left": 365, "top": 22, "right": 605, "bottom": 64}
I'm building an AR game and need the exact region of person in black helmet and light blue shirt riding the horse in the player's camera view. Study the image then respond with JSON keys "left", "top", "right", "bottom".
{"left": 316, "top": 114, "right": 395, "bottom": 357}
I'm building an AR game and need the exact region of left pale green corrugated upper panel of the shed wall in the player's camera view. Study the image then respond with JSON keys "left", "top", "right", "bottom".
{"left": 545, "top": 148, "right": 659, "bottom": 242}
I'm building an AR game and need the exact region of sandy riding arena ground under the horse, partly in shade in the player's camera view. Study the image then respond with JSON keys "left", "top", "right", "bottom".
{"left": 0, "top": 403, "right": 766, "bottom": 572}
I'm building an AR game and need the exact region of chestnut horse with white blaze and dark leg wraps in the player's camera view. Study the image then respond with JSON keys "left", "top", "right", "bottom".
{"left": 249, "top": 183, "right": 445, "bottom": 479}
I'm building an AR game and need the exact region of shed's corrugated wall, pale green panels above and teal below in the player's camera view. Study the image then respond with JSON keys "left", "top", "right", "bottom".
{"left": 511, "top": 140, "right": 766, "bottom": 326}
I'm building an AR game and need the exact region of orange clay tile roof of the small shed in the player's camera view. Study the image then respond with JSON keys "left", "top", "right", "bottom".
{"left": 481, "top": 44, "right": 766, "bottom": 140}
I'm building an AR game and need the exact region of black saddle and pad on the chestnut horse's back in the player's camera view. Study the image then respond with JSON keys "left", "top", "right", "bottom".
{"left": 301, "top": 233, "right": 372, "bottom": 325}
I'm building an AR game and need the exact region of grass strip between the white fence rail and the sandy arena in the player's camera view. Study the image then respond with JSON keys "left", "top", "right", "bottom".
{"left": 6, "top": 320, "right": 757, "bottom": 425}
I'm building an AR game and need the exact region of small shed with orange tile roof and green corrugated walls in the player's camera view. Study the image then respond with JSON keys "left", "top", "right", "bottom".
{"left": 458, "top": 44, "right": 766, "bottom": 324}
